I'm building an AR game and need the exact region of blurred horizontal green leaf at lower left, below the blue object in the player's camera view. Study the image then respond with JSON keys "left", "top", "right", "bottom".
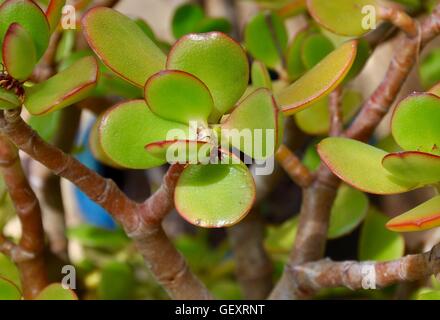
{"left": 67, "top": 224, "right": 130, "bottom": 250}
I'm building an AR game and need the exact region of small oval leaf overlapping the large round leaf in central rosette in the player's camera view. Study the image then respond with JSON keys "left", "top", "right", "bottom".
{"left": 144, "top": 70, "right": 214, "bottom": 125}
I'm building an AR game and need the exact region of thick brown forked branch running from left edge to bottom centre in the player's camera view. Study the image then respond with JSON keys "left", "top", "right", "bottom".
{"left": 0, "top": 110, "right": 212, "bottom": 299}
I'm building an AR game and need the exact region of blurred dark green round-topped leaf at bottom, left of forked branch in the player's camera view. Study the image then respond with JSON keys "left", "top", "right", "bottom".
{"left": 98, "top": 261, "right": 135, "bottom": 300}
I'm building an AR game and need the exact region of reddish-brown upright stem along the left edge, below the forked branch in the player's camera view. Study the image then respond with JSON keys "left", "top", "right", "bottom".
{"left": 0, "top": 135, "right": 48, "bottom": 299}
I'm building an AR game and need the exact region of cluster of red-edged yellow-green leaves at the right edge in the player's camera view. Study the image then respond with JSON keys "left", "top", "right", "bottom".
{"left": 318, "top": 86, "right": 440, "bottom": 231}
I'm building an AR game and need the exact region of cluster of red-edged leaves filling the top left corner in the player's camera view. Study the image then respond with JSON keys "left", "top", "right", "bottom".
{"left": 0, "top": 0, "right": 98, "bottom": 115}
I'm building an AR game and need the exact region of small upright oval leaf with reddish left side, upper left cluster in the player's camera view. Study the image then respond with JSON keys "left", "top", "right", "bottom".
{"left": 2, "top": 23, "right": 37, "bottom": 81}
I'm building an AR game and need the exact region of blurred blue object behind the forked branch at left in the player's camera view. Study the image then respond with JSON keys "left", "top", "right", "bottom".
{"left": 74, "top": 120, "right": 117, "bottom": 229}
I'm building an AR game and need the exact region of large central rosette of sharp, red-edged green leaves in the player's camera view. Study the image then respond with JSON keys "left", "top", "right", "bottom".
{"left": 83, "top": 8, "right": 356, "bottom": 227}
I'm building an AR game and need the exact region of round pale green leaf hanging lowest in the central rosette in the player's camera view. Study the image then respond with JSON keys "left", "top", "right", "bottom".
{"left": 174, "top": 153, "right": 255, "bottom": 228}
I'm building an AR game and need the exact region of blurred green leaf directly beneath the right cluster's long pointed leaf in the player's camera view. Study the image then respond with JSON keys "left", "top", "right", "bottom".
{"left": 327, "top": 184, "right": 368, "bottom": 239}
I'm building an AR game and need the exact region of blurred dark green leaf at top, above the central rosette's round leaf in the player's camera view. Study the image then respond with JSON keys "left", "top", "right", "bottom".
{"left": 171, "top": 3, "right": 205, "bottom": 39}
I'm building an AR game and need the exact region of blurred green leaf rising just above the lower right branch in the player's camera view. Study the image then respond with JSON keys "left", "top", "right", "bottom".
{"left": 359, "top": 209, "right": 405, "bottom": 261}
